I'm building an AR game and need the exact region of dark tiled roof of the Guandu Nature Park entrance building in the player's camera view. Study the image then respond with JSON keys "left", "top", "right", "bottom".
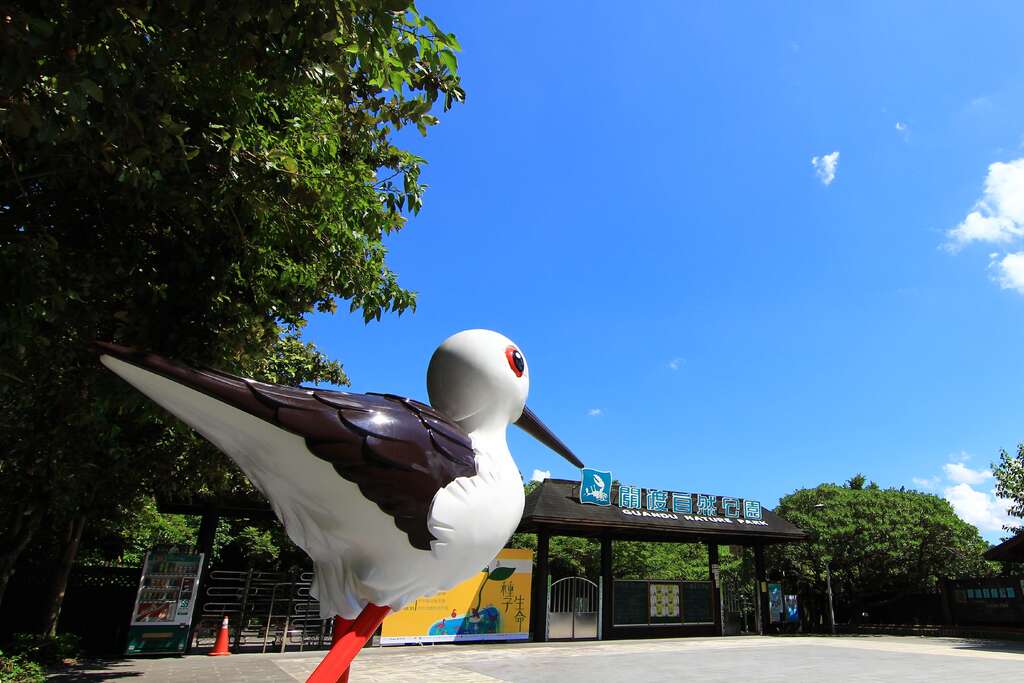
{"left": 519, "top": 479, "right": 807, "bottom": 545}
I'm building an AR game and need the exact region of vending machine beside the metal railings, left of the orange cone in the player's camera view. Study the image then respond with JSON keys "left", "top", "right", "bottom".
{"left": 126, "top": 550, "right": 203, "bottom": 654}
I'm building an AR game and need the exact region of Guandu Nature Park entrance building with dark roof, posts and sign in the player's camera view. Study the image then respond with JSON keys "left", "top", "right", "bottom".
{"left": 518, "top": 469, "right": 807, "bottom": 641}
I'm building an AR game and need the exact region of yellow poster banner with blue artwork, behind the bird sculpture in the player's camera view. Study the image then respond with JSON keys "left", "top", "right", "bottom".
{"left": 381, "top": 548, "right": 534, "bottom": 645}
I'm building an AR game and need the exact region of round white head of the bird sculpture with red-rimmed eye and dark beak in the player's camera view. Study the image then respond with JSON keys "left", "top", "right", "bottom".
{"left": 427, "top": 330, "right": 583, "bottom": 467}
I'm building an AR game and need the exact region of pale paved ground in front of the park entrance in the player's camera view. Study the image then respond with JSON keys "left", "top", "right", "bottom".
{"left": 51, "top": 636, "right": 1024, "bottom": 683}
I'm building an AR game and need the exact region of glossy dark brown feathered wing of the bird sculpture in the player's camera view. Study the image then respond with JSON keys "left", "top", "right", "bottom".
{"left": 96, "top": 343, "right": 476, "bottom": 550}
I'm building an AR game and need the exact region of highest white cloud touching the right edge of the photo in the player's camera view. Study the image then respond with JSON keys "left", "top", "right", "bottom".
{"left": 946, "top": 158, "right": 1024, "bottom": 251}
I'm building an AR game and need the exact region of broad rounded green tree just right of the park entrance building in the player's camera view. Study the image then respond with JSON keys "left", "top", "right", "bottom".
{"left": 768, "top": 477, "right": 992, "bottom": 618}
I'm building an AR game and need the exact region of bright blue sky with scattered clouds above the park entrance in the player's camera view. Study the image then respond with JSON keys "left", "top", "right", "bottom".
{"left": 306, "top": 2, "right": 1024, "bottom": 540}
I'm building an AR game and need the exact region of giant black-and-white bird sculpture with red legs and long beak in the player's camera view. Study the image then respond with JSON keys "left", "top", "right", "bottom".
{"left": 98, "top": 330, "right": 583, "bottom": 683}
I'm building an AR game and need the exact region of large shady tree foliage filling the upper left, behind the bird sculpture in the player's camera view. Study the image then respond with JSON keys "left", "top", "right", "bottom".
{"left": 0, "top": 0, "right": 464, "bottom": 626}
